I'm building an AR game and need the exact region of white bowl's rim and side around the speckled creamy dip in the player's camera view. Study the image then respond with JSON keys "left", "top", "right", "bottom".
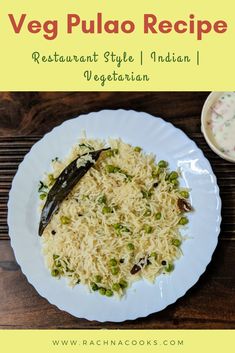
{"left": 201, "top": 92, "right": 235, "bottom": 163}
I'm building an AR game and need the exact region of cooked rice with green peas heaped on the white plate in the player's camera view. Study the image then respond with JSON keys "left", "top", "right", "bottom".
{"left": 39, "top": 138, "right": 189, "bottom": 295}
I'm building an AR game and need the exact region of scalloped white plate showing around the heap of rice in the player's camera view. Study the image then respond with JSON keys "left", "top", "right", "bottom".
{"left": 8, "top": 110, "right": 221, "bottom": 322}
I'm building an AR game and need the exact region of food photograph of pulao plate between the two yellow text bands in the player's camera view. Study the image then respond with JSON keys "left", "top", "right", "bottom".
{"left": 0, "top": 92, "right": 235, "bottom": 329}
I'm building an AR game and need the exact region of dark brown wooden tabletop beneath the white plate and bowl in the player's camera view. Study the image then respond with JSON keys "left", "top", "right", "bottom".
{"left": 0, "top": 92, "right": 235, "bottom": 329}
